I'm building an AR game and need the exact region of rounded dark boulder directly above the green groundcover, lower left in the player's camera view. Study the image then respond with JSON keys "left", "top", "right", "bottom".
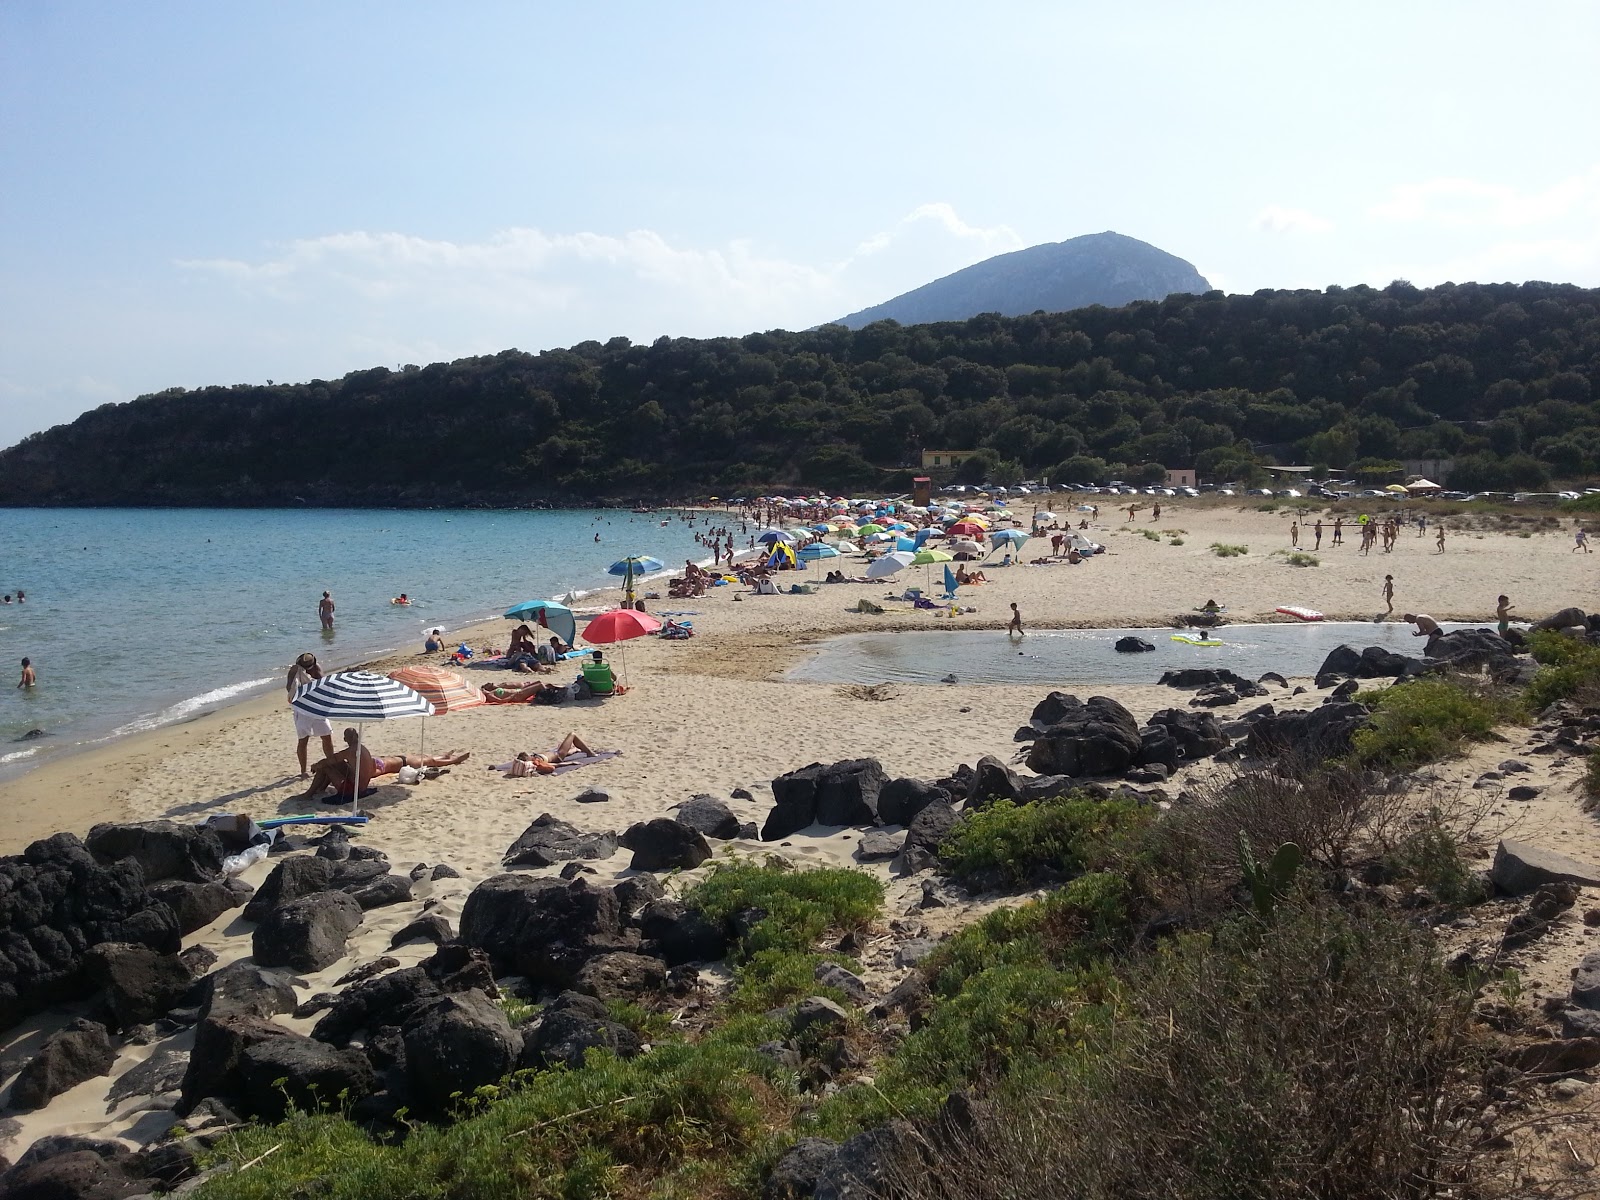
{"left": 405, "top": 990, "right": 522, "bottom": 1115}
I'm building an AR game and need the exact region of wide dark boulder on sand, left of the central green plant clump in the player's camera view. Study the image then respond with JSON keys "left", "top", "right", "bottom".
{"left": 459, "top": 875, "right": 637, "bottom": 987}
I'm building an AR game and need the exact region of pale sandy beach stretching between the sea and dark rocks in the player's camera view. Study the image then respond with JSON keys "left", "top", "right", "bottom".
{"left": 0, "top": 506, "right": 1600, "bottom": 1152}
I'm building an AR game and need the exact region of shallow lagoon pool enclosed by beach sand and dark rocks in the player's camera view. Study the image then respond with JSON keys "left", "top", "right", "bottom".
{"left": 787, "top": 621, "right": 1470, "bottom": 686}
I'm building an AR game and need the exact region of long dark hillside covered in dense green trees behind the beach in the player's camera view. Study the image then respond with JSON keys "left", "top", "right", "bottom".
{"left": 0, "top": 283, "right": 1600, "bottom": 504}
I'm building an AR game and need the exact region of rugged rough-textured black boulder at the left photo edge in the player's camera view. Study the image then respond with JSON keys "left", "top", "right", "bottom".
{"left": 0, "top": 834, "right": 181, "bottom": 1029}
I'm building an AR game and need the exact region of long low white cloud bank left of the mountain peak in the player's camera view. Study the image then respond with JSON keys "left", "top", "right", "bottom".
{"left": 178, "top": 203, "right": 1024, "bottom": 346}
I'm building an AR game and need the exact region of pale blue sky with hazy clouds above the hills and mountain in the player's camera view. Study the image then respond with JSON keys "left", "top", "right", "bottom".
{"left": 0, "top": 0, "right": 1600, "bottom": 445}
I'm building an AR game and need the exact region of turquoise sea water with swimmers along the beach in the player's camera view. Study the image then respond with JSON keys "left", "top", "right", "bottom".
{"left": 0, "top": 509, "right": 726, "bottom": 778}
